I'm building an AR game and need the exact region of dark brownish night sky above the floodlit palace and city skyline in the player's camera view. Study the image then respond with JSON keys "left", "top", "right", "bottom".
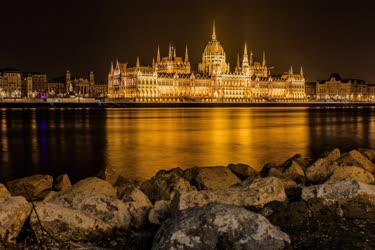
{"left": 0, "top": 0, "right": 375, "bottom": 82}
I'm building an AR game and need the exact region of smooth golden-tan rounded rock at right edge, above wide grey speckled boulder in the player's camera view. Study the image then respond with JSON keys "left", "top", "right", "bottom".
{"left": 326, "top": 166, "right": 375, "bottom": 184}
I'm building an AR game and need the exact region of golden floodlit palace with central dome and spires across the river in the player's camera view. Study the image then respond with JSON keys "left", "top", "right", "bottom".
{"left": 108, "top": 24, "right": 306, "bottom": 102}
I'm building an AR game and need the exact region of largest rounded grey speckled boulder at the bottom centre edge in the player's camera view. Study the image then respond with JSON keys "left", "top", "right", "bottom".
{"left": 152, "top": 204, "right": 290, "bottom": 249}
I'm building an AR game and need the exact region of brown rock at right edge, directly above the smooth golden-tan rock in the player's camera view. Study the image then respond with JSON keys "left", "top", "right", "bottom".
{"left": 336, "top": 150, "right": 375, "bottom": 173}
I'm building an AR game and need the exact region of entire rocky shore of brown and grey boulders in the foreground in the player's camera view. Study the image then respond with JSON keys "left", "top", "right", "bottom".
{"left": 0, "top": 149, "right": 375, "bottom": 249}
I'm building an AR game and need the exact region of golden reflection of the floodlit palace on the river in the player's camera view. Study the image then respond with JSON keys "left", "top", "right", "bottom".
{"left": 106, "top": 108, "right": 309, "bottom": 179}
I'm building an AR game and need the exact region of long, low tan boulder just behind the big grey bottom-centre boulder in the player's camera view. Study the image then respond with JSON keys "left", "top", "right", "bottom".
{"left": 172, "top": 177, "right": 286, "bottom": 210}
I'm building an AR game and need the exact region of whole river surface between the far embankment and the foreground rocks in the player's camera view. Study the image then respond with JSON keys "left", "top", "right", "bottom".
{"left": 0, "top": 107, "right": 375, "bottom": 182}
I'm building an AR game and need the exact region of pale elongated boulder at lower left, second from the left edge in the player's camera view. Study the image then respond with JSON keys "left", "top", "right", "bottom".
{"left": 30, "top": 203, "right": 112, "bottom": 241}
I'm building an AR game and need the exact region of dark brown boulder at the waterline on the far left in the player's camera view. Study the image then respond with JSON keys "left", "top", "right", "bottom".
{"left": 7, "top": 175, "right": 53, "bottom": 201}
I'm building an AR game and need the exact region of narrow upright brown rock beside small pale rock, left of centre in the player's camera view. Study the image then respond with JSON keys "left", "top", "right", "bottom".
{"left": 117, "top": 184, "right": 152, "bottom": 228}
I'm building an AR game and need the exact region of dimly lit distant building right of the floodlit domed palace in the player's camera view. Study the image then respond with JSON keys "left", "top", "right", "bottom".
{"left": 316, "top": 73, "right": 375, "bottom": 101}
